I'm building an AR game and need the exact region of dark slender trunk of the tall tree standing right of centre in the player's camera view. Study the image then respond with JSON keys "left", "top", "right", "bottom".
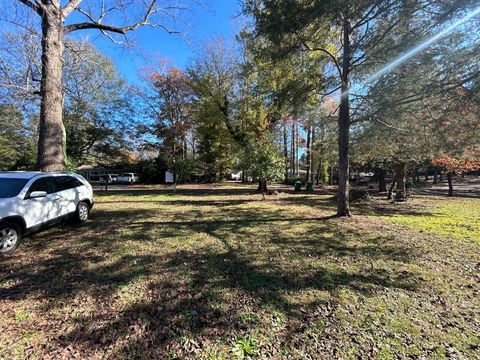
{"left": 337, "top": 19, "right": 351, "bottom": 216}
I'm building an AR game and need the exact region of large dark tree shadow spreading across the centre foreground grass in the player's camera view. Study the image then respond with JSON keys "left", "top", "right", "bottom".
{"left": 47, "top": 232, "right": 416, "bottom": 358}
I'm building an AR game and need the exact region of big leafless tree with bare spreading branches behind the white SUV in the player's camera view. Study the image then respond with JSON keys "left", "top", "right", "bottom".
{"left": 11, "top": 0, "right": 194, "bottom": 171}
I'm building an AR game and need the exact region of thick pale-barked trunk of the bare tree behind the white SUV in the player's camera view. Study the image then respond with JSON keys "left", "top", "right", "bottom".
{"left": 37, "top": 8, "right": 66, "bottom": 171}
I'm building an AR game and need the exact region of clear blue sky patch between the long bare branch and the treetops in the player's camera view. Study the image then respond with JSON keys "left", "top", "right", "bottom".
{"left": 77, "top": 0, "right": 242, "bottom": 83}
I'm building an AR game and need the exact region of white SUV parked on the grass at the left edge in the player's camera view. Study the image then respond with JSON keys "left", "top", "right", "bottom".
{"left": 0, "top": 172, "right": 93, "bottom": 255}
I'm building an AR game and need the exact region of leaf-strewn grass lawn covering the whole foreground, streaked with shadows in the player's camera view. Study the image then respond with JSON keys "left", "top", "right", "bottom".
{"left": 0, "top": 185, "right": 480, "bottom": 359}
